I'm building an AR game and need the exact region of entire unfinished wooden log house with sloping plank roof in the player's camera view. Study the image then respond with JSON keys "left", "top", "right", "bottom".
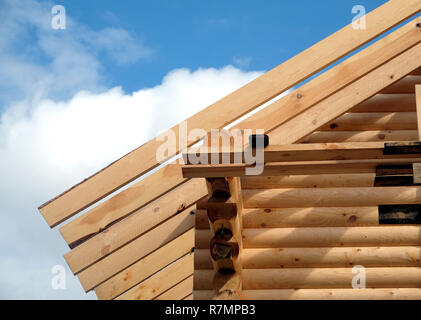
{"left": 39, "top": 0, "right": 421, "bottom": 299}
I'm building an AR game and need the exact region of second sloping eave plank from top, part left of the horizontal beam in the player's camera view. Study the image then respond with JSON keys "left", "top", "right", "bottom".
{"left": 60, "top": 165, "right": 194, "bottom": 247}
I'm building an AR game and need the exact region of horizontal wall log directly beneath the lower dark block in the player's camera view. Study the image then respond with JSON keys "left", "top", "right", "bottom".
{"left": 241, "top": 226, "right": 421, "bottom": 248}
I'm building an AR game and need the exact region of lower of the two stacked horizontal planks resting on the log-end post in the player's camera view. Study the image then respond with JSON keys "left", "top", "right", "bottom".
{"left": 183, "top": 158, "right": 421, "bottom": 178}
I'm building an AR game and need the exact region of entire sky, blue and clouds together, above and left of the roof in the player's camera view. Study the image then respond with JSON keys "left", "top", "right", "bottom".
{"left": 0, "top": 0, "right": 410, "bottom": 299}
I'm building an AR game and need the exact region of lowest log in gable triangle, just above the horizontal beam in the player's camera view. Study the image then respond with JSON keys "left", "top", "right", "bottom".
{"left": 300, "top": 130, "right": 418, "bottom": 143}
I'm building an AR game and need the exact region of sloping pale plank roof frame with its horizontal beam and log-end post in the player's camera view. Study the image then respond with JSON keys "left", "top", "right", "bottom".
{"left": 39, "top": 0, "right": 421, "bottom": 299}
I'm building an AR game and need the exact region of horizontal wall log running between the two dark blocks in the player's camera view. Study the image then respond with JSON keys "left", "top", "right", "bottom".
{"left": 243, "top": 186, "right": 421, "bottom": 208}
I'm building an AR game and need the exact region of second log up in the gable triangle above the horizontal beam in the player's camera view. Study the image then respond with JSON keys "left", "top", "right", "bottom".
{"left": 318, "top": 112, "right": 417, "bottom": 131}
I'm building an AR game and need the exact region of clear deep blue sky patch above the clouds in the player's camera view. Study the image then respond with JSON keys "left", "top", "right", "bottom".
{"left": 20, "top": 0, "right": 385, "bottom": 92}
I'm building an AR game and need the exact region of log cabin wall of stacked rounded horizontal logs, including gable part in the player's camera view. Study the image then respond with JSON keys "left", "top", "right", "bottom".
{"left": 193, "top": 70, "right": 421, "bottom": 299}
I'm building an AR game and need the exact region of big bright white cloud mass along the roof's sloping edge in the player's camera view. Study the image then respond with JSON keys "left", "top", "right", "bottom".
{"left": 0, "top": 66, "right": 260, "bottom": 298}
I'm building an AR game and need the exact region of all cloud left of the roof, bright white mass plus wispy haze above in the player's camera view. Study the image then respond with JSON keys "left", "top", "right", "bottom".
{"left": 0, "top": 0, "right": 261, "bottom": 299}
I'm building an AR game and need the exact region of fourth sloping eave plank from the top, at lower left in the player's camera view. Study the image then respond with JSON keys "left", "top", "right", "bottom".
{"left": 78, "top": 208, "right": 194, "bottom": 291}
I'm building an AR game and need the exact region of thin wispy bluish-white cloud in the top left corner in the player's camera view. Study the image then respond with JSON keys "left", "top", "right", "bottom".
{"left": 0, "top": 0, "right": 152, "bottom": 109}
